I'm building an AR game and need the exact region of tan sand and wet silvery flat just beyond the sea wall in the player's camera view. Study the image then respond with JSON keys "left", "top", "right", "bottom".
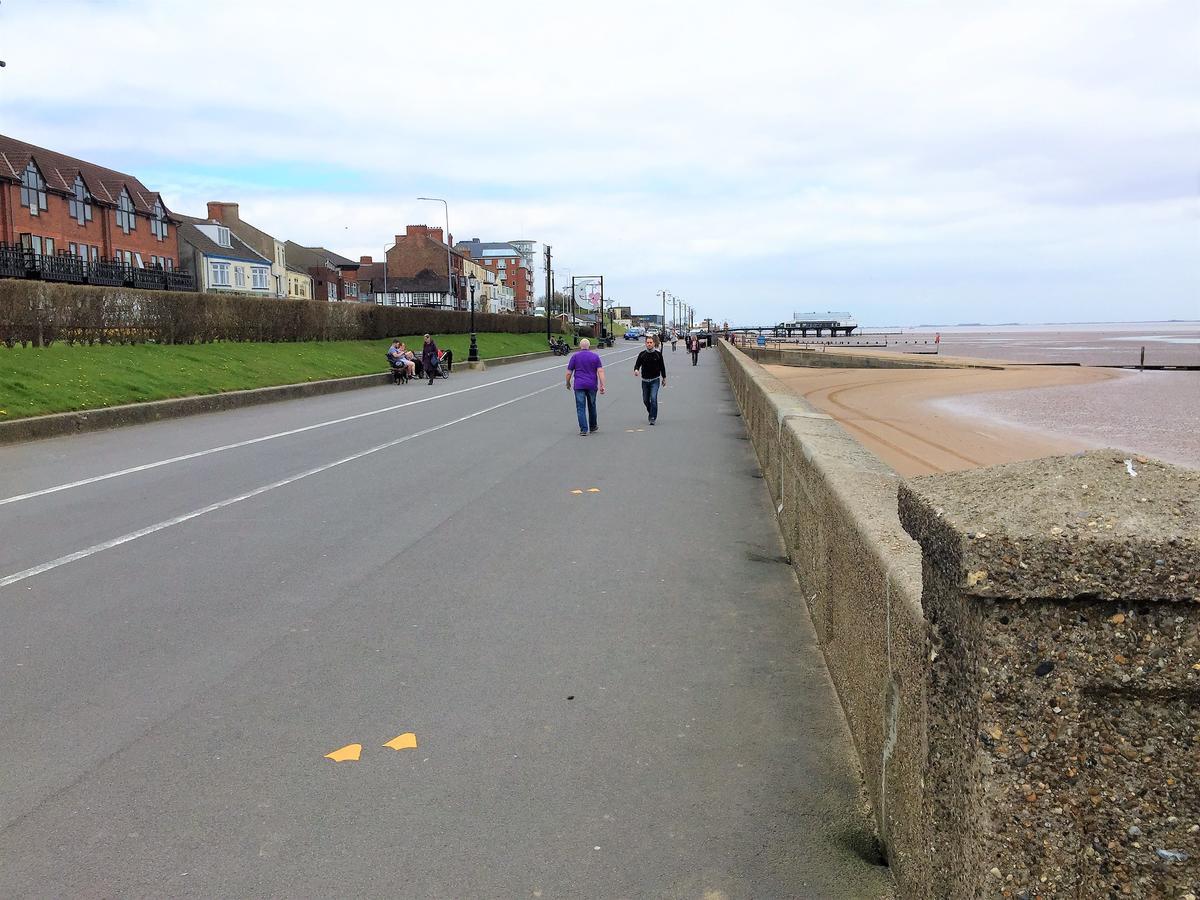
{"left": 767, "top": 361, "right": 1200, "bottom": 475}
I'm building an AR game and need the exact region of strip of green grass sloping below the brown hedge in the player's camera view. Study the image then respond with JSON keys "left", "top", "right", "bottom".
{"left": 0, "top": 334, "right": 546, "bottom": 421}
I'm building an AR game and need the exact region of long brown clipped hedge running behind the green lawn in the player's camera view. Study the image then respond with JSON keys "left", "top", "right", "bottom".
{"left": 0, "top": 278, "right": 560, "bottom": 347}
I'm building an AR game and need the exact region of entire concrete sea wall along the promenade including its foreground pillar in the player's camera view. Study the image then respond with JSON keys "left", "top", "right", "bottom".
{"left": 719, "top": 342, "right": 1200, "bottom": 898}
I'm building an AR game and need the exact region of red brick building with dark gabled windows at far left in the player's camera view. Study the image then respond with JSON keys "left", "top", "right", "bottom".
{"left": 0, "top": 134, "right": 179, "bottom": 271}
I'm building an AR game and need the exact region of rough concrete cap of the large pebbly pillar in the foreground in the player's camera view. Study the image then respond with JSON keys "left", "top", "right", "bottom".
{"left": 899, "top": 450, "right": 1200, "bottom": 600}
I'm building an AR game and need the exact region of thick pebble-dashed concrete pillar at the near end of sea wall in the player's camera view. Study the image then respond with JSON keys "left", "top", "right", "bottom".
{"left": 899, "top": 450, "right": 1200, "bottom": 898}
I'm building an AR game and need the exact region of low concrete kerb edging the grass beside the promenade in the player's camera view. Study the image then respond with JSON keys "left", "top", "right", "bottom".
{"left": 0, "top": 350, "right": 553, "bottom": 446}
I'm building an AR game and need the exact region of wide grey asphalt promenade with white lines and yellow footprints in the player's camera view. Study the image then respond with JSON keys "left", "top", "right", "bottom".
{"left": 0, "top": 346, "right": 888, "bottom": 900}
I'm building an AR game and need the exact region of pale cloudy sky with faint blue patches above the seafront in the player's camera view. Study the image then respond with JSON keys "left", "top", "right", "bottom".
{"left": 0, "top": 0, "right": 1200, "bottom": 325}
